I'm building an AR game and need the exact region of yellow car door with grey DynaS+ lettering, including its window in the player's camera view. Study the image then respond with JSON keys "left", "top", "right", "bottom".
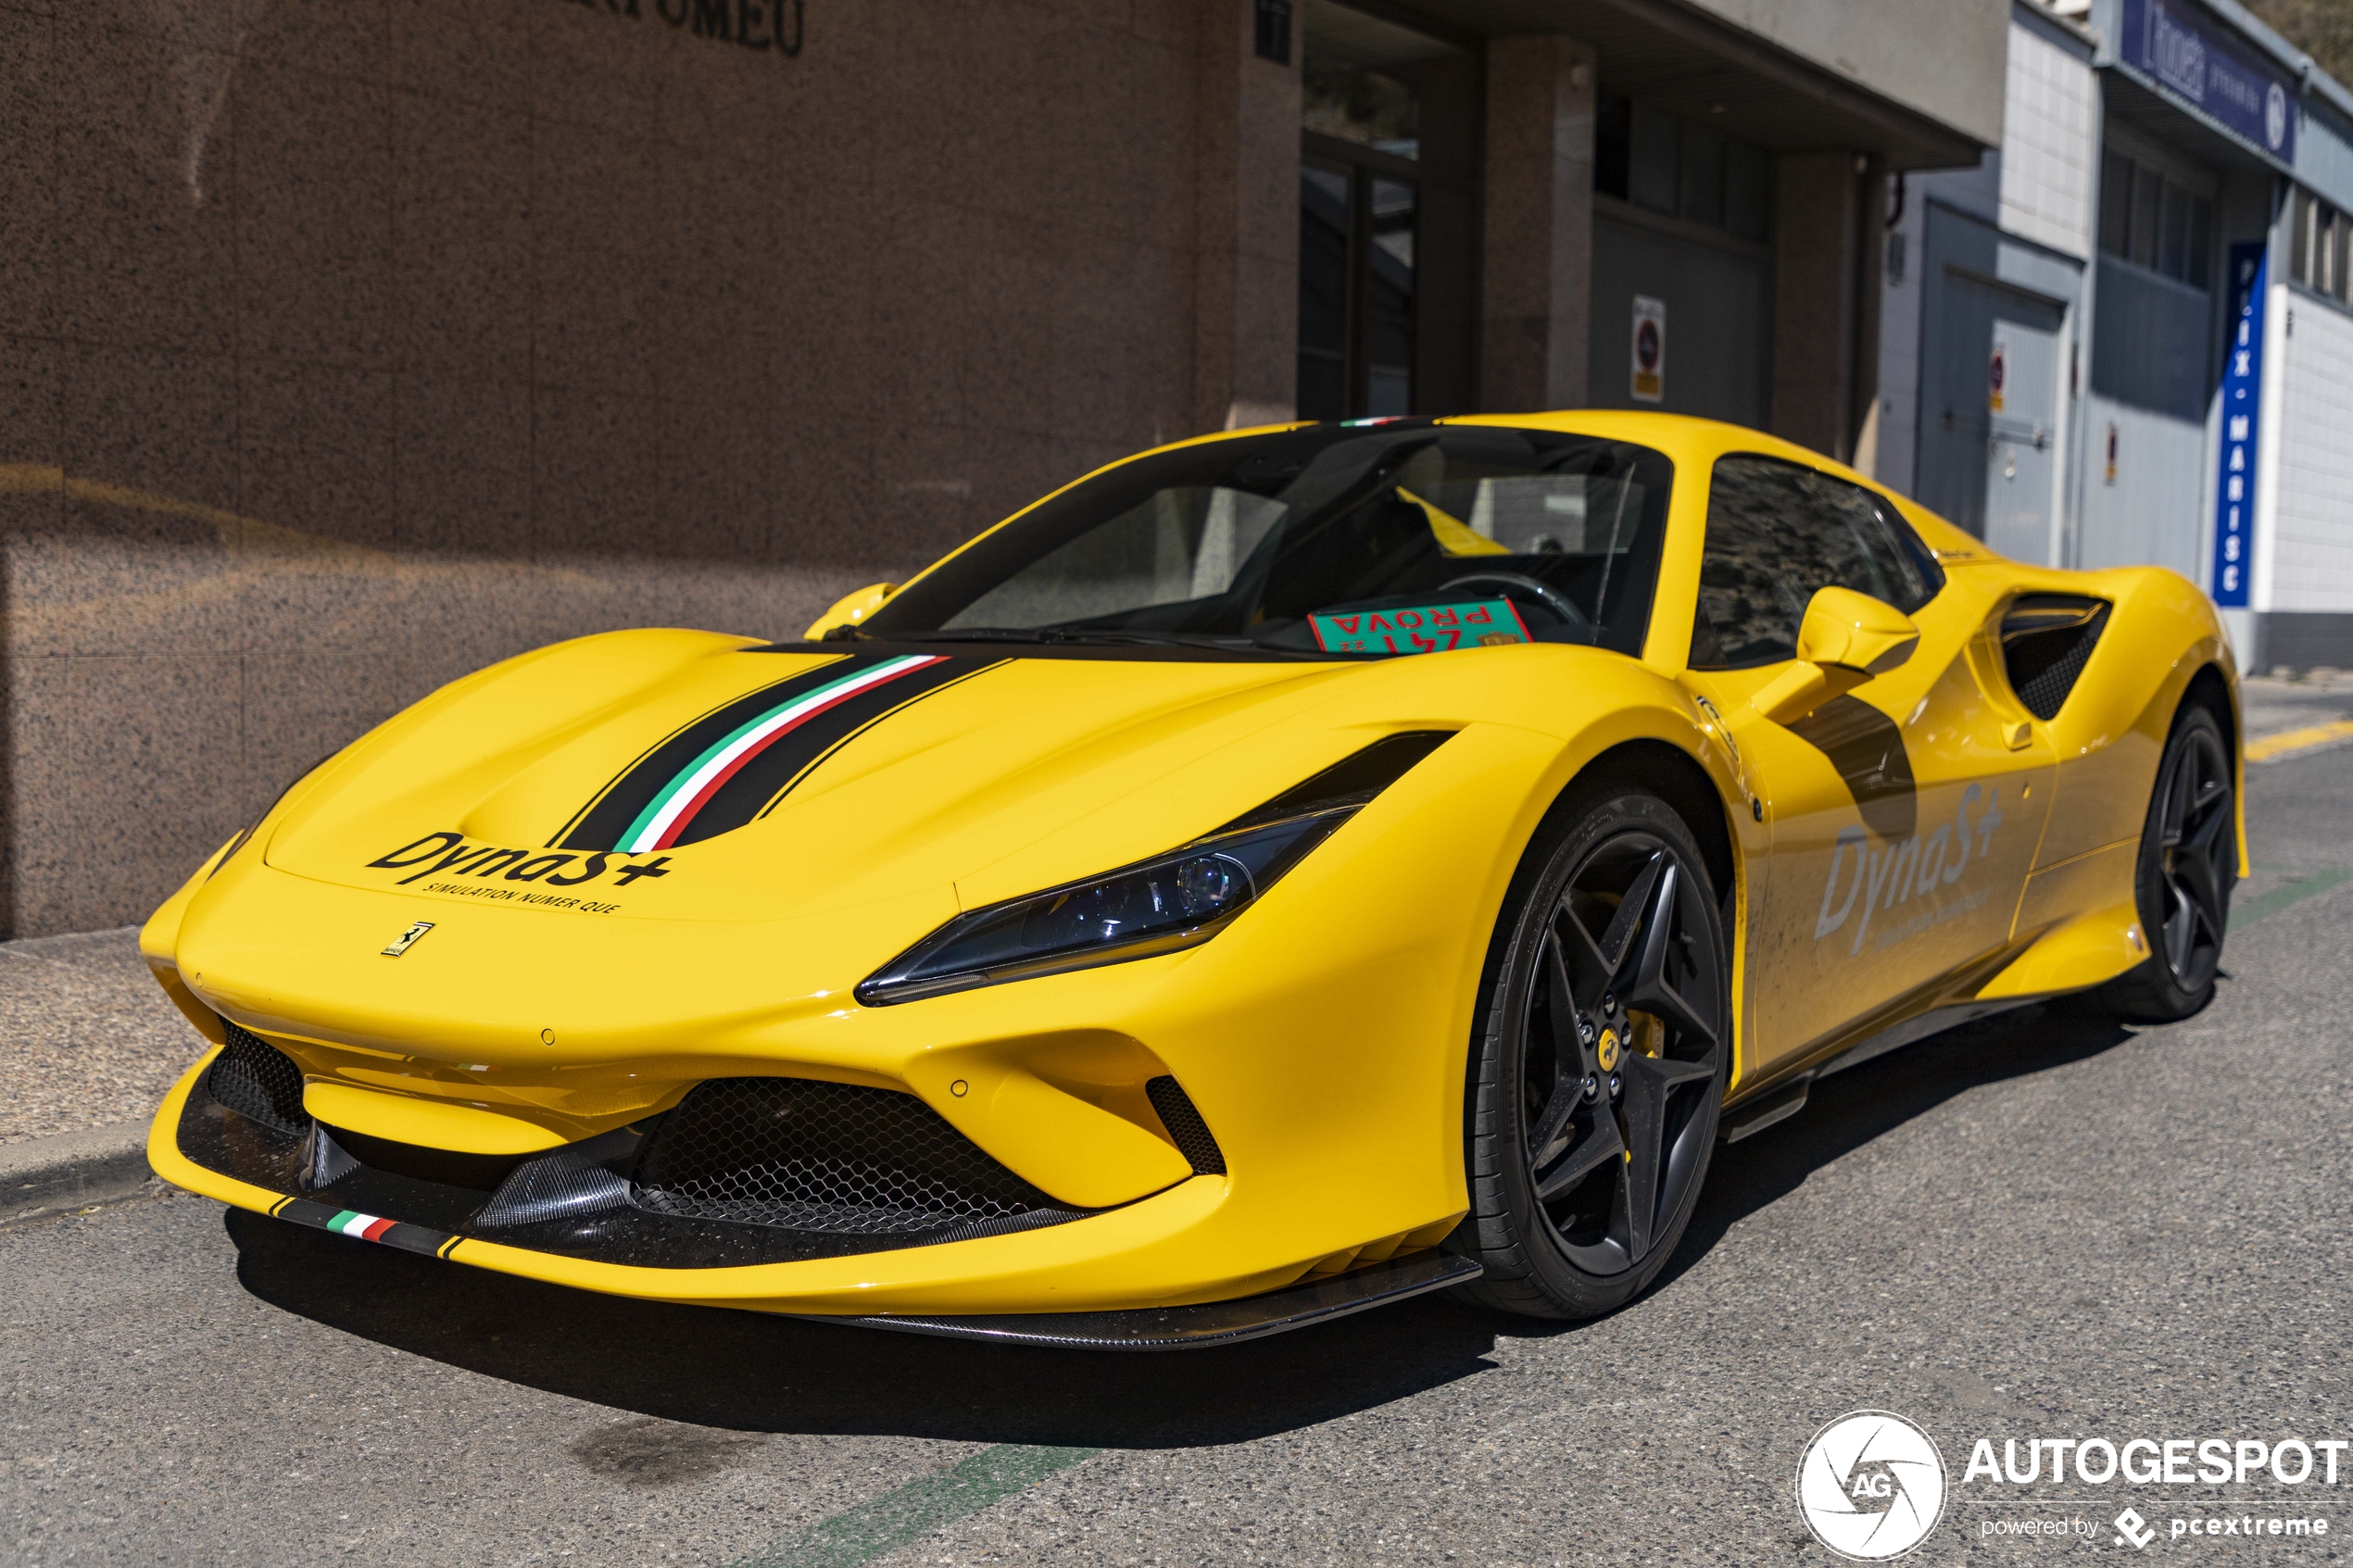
{"left": 1685, "top": 454, "right": 2057, "bottom": 1077}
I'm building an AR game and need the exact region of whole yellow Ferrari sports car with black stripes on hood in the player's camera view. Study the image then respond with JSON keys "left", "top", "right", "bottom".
{"left": 141, "top": 411, "right": 2243, "bottom": 1349}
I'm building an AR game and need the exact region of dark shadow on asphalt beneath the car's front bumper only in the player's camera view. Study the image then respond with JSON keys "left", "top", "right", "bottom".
{"left": 228, "top": 1209, "right": 1499, "bottom": 1449}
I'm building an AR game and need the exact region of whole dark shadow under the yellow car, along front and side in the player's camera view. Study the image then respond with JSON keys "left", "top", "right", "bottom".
{"left": 228, "top": 1009, "right": 2130, "bottom": 1449}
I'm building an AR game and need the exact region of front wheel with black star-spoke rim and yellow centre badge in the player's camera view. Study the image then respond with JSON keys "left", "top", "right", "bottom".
{"left": 1450, "top": 785, "right": 1731, "bottom": 1319}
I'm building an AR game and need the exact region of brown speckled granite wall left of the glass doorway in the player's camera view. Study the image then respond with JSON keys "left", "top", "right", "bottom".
{"left": 0, "top": 0, "right": 1297, "bottom": 935}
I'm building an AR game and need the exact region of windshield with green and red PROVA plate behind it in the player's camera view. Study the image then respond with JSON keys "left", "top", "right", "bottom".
{"left": 859, "top": 420, "right": 1673, "bottom": 656}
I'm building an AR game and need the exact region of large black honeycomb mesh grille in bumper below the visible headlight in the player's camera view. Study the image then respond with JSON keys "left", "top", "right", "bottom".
{"left": 635, "top": 1079, "right": 1068, "bottom": 1235}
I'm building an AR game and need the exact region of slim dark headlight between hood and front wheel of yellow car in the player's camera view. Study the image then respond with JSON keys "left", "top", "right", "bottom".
{"left": 857, "top": 802, "right": 1360, "bottom": 1006}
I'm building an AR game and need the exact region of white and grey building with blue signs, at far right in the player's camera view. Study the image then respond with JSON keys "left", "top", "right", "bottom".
{"left": 1878, "top": 0, "right": 2353, "bottom": 670}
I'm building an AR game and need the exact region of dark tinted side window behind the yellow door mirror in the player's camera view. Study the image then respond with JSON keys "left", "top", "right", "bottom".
{"left": 1692, "top": 454, "right": 1944, "bottom": 670}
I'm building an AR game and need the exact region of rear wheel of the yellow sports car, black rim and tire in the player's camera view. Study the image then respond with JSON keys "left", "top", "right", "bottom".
{"left": 2095, "top": 700, "right": 2238, "bottom": 1022}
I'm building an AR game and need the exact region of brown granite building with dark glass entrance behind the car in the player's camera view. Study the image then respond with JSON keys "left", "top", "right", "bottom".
{"left": 0, "top": 0, "right": 2007, "bottom": 935}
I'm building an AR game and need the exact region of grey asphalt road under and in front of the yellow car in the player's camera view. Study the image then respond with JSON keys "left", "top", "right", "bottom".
{"left": 0, "top": 728, "right": 2353, "bottom": 1568}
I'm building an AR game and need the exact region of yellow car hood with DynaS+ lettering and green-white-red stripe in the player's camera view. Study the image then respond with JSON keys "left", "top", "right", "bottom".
{"left": 266, "top": 633, "right": 1421, "bottom": 922}
